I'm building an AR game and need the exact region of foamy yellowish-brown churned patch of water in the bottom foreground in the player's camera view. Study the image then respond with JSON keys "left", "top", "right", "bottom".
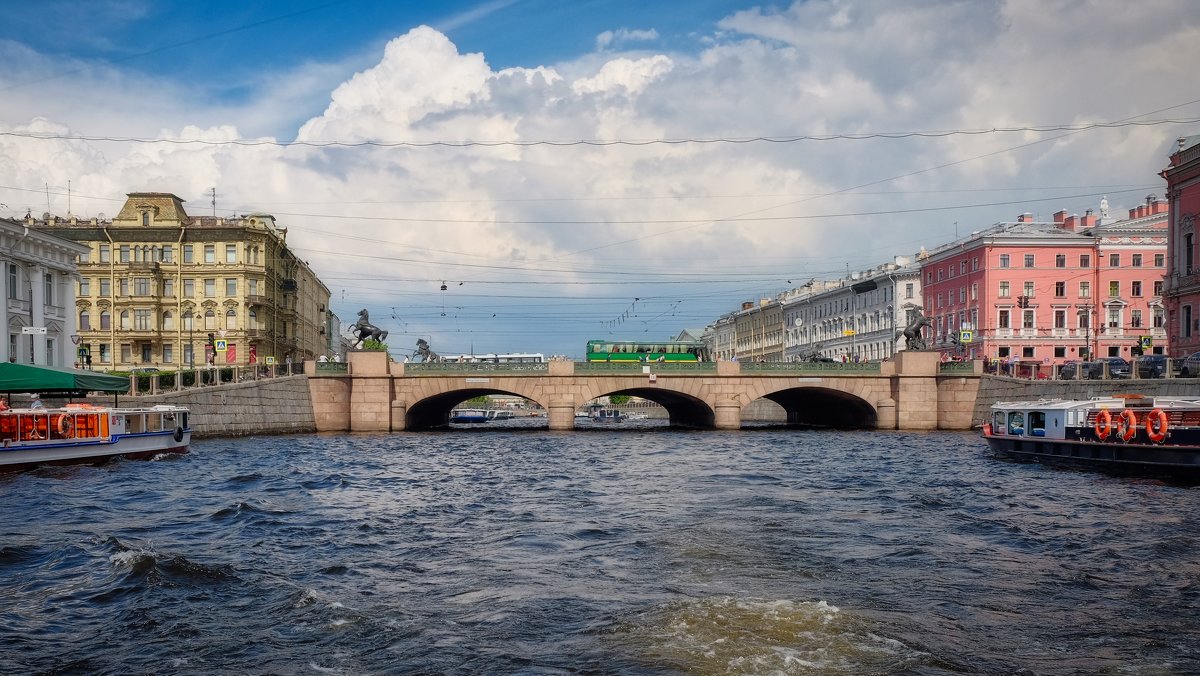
{"left": 617, "top": 597, "right": 924, "bottom": 674}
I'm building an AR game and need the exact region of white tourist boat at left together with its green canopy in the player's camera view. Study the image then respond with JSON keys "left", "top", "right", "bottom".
{"left": 0, "top": 363, "right": 192, "bottom": 471}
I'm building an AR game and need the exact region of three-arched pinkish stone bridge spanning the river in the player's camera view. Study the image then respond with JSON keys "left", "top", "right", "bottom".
{"left": 305, "top": 352, "right": 983, "bottom": 432}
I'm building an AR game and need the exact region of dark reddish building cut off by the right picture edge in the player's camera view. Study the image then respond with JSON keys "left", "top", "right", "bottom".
{"left": 1162, "top": 136, "right": 1200, "bottom": 358}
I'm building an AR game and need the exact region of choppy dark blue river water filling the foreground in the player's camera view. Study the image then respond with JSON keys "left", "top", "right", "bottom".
{"left": 0, "top": 421, "right": 1200, "bottom": 675}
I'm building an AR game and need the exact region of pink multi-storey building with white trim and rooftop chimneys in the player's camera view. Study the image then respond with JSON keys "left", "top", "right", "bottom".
{"left": 922, "top": 196, "right": 1166, "bottom": 367}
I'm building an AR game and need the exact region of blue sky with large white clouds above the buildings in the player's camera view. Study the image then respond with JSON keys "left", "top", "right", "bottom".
{"left": 0, "top": 0, "right": 1200, "bottom": 358}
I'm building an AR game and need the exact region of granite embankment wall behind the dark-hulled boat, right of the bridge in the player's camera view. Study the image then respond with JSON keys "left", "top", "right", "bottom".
{"left": 973, "top": 375, "right": 1200, "bottom": 421}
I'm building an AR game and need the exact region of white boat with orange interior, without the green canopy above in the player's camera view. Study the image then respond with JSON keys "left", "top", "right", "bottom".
{"left": 0, "top": 403, "right": 192, "bottom": 471}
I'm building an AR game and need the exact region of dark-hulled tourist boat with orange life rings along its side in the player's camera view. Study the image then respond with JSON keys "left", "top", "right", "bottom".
{"left": 983, "top": 395, "right": 1200, "bottom": 483}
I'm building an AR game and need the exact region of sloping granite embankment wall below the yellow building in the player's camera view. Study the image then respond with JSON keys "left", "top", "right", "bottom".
{"left": 92, "top": 376, "right": 317, "bottom": 438}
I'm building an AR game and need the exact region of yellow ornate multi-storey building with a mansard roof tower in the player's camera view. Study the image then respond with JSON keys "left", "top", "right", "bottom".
{"left": 33, "top": 192, "right": 330, "bottom": 371}
